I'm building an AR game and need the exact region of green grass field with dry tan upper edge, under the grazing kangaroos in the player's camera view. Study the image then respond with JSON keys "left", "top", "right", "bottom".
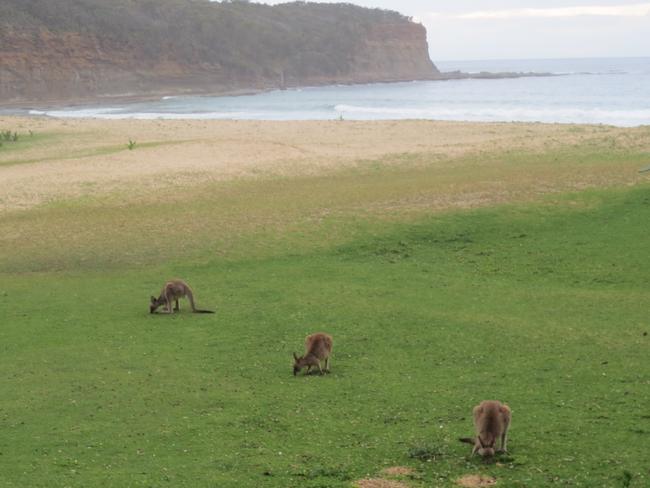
{"left": 0, "top": 127, "right": 650, "bottom": 488}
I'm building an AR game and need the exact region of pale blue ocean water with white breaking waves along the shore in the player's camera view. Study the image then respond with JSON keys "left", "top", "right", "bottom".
{"left": 20, "top": 58, "right": 650, "bottom": 127}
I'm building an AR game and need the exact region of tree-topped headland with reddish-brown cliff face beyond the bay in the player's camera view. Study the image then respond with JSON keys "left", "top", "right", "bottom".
{"left": 0, "top": 0, "right": 438, "bottom": 103}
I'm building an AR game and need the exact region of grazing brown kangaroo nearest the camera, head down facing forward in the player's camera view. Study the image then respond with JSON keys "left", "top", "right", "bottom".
{"left": 459, "top": 400, "right": 512, "bottom": 457}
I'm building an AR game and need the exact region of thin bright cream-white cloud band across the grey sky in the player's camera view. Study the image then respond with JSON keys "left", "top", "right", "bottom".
{"left": 427, "top": 3, "right": 650, "bottom": 20}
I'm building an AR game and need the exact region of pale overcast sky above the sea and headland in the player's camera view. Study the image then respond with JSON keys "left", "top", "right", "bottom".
{"left": 254, "top": 0, "right": 650, "bottom": 62}
